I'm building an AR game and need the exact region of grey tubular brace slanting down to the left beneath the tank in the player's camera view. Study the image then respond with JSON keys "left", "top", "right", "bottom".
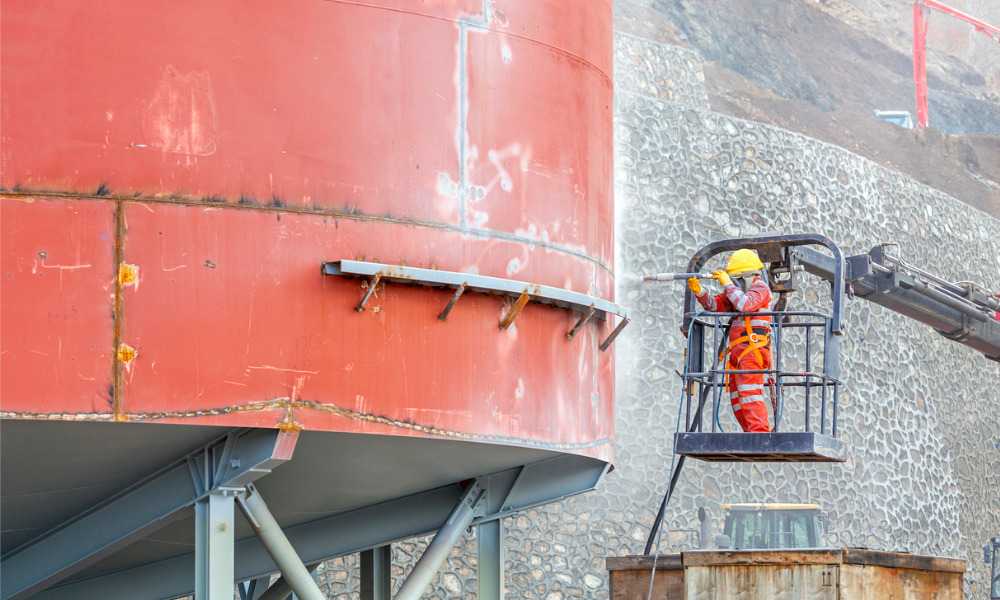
{"left": 396, "top": 479, "right": 486, "bottom": 600}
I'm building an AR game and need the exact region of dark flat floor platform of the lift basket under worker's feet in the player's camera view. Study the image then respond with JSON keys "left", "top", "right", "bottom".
{"left": 677, "top": 431, "right": 847, "bottom": 462}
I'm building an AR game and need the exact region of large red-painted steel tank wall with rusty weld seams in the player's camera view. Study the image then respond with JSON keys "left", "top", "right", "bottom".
{"left": 0, "top": 0, "right": 615, "bottom": 459}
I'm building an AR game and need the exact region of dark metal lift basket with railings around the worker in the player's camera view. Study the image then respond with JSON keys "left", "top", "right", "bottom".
{"left": 675, "top": 235, "right": 847, "bottom": 462}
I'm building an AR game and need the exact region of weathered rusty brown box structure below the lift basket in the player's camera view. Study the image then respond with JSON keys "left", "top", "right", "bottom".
{"left": 606, "top": 548, "right": 966, "bottom": 600}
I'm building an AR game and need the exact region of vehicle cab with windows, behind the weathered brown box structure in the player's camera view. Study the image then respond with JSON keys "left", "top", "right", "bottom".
{"left": 722, "top": 504, "right": 829, "bottom": 550}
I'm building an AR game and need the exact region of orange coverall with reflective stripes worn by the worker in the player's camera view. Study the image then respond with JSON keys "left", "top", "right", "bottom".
{"left": 695, "top": 276, "right": 772, "bottom": 433}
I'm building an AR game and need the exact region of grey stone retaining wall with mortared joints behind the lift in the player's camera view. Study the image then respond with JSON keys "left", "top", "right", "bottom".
{"left": 603, "top": 36, "right": 1000, "bottom": 597}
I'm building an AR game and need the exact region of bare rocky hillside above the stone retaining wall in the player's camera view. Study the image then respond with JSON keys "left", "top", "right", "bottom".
{"left": 615, "top": 0, "right": 1000, "bottom": 217}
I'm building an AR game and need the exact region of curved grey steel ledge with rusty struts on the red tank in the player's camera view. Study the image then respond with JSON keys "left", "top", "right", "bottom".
{"left": 322, "top": 260, "right": 629, "bottom": 351}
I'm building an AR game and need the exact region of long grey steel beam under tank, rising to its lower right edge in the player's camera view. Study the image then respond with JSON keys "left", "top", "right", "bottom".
{"left": 34, "top": 452, "right": 609, "bottom": 600}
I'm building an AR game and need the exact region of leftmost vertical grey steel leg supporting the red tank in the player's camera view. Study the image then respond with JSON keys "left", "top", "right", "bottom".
{"left": 194, "top": 491, "right": 235, "bottom": 600}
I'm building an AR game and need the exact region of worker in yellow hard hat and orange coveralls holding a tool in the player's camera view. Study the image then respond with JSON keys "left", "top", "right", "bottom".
{"left": 688, "top": 249, "right": 772, "bottom": 433}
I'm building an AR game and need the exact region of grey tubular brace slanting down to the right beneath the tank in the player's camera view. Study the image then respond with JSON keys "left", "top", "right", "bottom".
{"left": 236, "top": 485, "right": 326, "bottom": 600}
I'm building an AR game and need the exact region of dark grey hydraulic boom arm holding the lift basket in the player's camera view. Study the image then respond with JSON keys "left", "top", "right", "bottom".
{"left": 788, "top": 246, "right": 1000, "bottom": 362}
